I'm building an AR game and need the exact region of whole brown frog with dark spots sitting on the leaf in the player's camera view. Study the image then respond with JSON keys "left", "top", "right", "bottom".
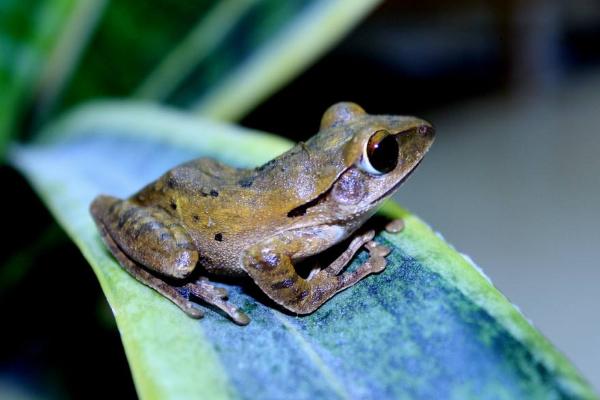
{"left": 90, "top": 102, "right": 435, "bottom": 325}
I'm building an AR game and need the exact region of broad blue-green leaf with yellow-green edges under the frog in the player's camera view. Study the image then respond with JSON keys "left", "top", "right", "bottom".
{"left": 11, "top": 102, "right": 596, "bottom": 399}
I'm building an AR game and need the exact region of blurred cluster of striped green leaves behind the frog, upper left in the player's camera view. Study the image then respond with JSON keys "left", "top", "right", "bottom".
{"left": 0, "top": 0, "right": 378, "bottom": 153}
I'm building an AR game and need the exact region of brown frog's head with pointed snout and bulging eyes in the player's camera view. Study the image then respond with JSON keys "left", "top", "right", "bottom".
{"left": 290, "top": 103, "right": 434, "bottom": 225}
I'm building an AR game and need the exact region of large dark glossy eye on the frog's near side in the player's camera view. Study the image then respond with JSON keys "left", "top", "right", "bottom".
{"left": 359, "top": 130, "right": 400, "bottom": 175}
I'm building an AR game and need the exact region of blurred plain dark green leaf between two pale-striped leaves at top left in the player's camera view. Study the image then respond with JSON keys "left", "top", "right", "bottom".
{"left": 63, "top": 0, "right": 217, "bottom": 106}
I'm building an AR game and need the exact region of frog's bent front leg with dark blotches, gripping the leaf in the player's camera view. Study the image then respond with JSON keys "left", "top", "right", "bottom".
{"left": 243, "top": 231, "right": 389, "bottom": 314}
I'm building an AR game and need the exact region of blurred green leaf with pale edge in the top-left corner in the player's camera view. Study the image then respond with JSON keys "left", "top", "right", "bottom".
{"left": 0, "top": 0, "right": 104, "bottom": 156}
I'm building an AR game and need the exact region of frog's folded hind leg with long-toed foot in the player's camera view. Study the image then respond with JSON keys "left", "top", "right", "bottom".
{"left": 91, "top": 196, "right": 250, "bottom": 325}
